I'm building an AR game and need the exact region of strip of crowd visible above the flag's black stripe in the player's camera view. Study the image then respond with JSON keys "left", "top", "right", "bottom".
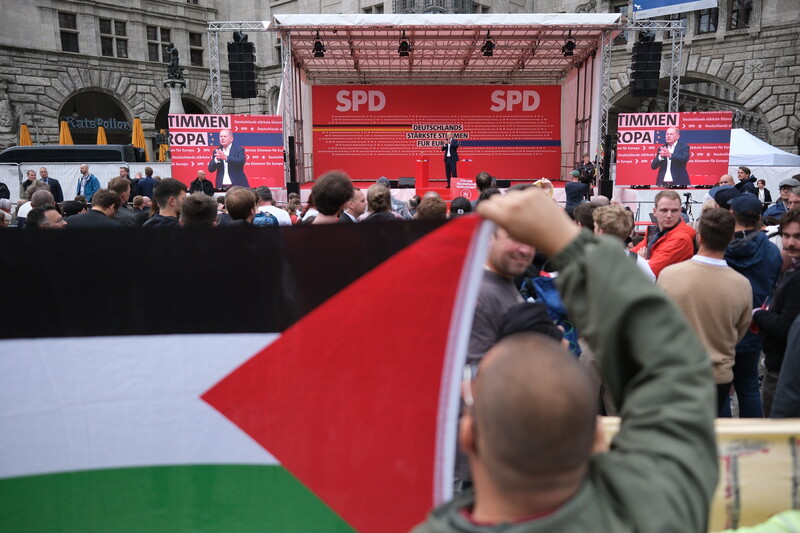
{"left": 0, "top": 164, "right": 482, "bottom": 230}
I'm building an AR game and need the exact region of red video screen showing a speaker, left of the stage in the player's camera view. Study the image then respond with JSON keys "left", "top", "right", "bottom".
{"left": 169, "top": 115, "right": 285, "bottom": 189}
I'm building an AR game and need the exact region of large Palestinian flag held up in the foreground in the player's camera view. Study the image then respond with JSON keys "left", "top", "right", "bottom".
{"left": 0, "top": 218, "right": 486, "bottom": 533}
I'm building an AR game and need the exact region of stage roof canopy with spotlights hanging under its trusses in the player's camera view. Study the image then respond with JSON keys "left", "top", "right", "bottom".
{"left": 278, "top": 15, "right": 623, "bottom": 85}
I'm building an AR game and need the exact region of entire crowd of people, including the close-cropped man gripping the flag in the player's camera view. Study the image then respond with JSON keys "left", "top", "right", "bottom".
{"left": 0, "top": 161, "right": 800, "bottom": 533}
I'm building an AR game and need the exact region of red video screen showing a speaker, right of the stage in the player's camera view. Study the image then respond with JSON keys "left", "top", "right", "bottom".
{"left": 616, "top": 111, "right": 733, "bottom": 187}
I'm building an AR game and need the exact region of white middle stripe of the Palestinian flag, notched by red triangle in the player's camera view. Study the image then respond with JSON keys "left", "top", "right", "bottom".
{"left": 0, "top": 333, "right": 279, "bottom": 478}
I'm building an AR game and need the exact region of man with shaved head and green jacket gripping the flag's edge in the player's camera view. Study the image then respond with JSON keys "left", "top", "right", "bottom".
{"left": 415, "top": 187, "right": 718, "bottom": 533}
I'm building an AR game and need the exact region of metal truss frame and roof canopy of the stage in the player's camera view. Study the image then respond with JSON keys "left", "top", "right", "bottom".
{"left": 208, "top": 13, "right": 636, "bottom": 182}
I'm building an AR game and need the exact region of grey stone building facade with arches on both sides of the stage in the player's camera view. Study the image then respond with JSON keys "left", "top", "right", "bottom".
{"left": 0, "top": 0, "right": 800, "bottom": 156}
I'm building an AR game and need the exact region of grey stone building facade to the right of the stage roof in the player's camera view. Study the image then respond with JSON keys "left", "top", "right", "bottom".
{"left": 605, "top": 0, "right": 800, "bottom": 153}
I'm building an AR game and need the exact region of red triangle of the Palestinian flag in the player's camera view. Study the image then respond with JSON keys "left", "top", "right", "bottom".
{"left": 202, "top": 217, "right": 479, "bottom": 533}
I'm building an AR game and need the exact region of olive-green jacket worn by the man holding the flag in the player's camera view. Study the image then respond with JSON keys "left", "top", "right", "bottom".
{"left": 414, "top": 231, "right": 718, "bottom": 533}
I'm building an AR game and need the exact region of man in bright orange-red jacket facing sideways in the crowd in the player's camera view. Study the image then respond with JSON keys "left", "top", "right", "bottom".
{"left": 633, "top": 190, "right": 695, "bottom": 277}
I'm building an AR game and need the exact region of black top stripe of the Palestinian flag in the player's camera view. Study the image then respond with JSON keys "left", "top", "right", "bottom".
{"left": 0, "top": 221, "right": 441, "bottom": 338}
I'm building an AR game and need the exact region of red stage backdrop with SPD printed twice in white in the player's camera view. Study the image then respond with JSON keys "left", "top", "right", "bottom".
{"left": 312, "top": 85, "right": 561, "bottom": 179}
